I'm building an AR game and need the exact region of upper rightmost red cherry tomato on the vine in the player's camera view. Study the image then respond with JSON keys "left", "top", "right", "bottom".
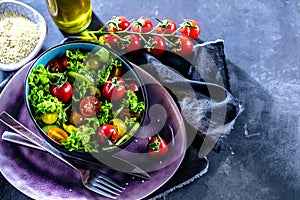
{"left": 180, "top": 19, "right": 201, "bottom": 40}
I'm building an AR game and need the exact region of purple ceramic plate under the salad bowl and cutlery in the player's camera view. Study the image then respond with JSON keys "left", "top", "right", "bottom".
{"left": 0, "top": 61, "right": 186, "bottom": 200}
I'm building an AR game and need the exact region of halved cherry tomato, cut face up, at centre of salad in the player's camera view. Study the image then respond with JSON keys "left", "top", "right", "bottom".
{"left": 79, "top": 96, "right": 100, "bottom": 117}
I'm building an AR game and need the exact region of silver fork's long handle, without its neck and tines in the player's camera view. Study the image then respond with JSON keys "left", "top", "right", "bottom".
{"left": 0, "top": 111, "right": 78, "bottom": 170}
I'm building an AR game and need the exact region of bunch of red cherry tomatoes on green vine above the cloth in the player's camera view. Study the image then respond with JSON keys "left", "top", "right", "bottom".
{"left": 71, "top": 16, "right": 200, "bottom": 56}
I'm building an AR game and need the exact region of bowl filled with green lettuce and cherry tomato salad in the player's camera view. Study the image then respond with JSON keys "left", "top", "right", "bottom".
{"left": 25, "top": 42, "right": 147, "bottom": 158}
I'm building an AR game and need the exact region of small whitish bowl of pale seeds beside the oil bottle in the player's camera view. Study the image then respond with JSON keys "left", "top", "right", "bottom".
{"left": 0, "top": 0, "right": 47, "bottom": 71}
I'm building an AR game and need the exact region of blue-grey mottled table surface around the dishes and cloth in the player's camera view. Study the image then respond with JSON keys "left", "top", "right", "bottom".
{"left": 0, "top": 0, "right": 300, "bottom": 200}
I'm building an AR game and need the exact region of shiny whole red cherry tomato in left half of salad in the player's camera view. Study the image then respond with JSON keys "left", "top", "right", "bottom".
{"left": 51, "top": 81, "right": 73, "bottom": 103}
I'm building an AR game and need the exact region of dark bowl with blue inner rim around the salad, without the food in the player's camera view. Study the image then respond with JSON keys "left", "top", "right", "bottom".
{"left": 25, "top": 42, "right": 147, "bottom": 160}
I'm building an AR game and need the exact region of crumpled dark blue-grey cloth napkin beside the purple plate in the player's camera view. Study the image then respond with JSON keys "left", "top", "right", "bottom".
{"left": 124, "top": 40, "right": 242, "bottom": 198}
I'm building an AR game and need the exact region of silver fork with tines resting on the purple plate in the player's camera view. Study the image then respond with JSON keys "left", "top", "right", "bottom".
{"left": 0, "top": 111, "right": 125, "bottom": 199}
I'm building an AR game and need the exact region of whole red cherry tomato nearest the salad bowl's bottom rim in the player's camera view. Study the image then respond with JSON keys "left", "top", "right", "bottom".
{"left": 96, "top": 124, "right": 118, "bottom": 143}
